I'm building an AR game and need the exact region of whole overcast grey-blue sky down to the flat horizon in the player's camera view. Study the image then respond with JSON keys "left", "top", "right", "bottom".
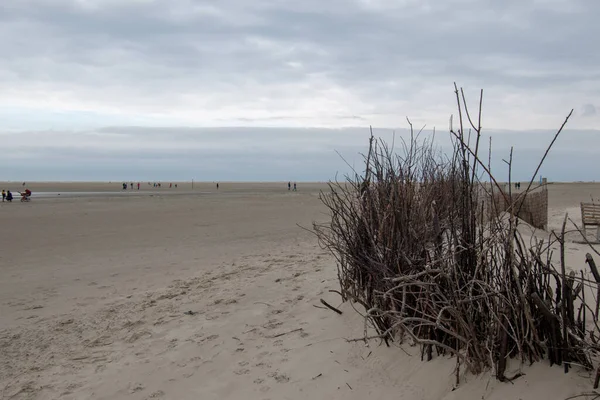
{"left": 0, "top": 0, "right": 600, "bottom": 181}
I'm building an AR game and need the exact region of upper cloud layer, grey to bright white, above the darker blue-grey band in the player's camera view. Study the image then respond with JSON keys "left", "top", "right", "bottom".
{"left": 0, "top": 0, "right": 600, "bottom": 129}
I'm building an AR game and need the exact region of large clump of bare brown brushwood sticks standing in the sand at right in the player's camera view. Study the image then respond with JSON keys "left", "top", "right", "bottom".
{"left": 313, "top": 89, "right": 600, "bottom": 381}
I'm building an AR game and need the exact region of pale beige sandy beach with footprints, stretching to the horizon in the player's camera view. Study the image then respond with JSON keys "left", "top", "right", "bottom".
{"left": 0, "top": 183, "right": 600, "bottom": 400}
